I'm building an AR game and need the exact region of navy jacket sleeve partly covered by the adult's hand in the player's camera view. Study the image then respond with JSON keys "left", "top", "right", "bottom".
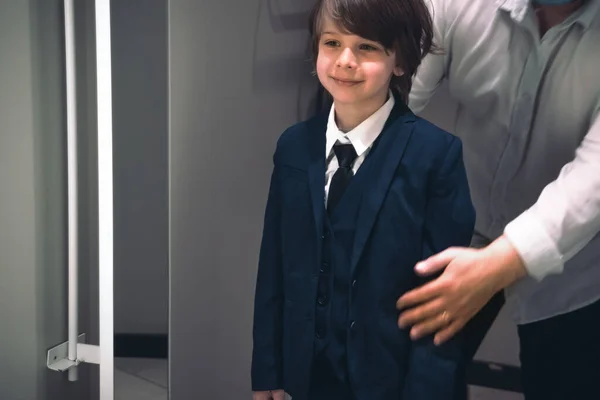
{"left": 402, "top": 138, "right": 475, "bottom": 400}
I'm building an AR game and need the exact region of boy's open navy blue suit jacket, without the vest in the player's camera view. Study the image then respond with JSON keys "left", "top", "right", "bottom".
{"left": 252, "top": 101, "right": 475, "bottom": 400}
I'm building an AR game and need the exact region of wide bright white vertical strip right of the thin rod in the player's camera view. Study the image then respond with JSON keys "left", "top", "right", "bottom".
{"left": 96, "top": 0, "right": 114, "bottom": 400}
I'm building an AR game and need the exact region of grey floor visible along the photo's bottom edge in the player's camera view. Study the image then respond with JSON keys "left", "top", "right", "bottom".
{"left": 115, "top": 358, "right": 523, "bottom": 400}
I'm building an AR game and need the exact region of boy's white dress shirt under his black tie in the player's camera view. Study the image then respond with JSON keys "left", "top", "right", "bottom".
{"left": 325, "top": 92, "right": 394, "bottom": 204}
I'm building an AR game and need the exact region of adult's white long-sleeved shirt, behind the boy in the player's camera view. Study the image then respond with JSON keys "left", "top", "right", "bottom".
{"left": 409, "top": 0, "right": 600, "bottom": 323}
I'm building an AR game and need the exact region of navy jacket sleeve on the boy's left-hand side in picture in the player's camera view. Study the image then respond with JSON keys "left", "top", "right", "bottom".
{"left": 251, "top": 146, "right": 284, "bottom": 391}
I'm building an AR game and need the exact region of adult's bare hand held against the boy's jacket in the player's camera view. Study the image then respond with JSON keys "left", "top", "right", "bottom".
{"left": 396, "top": 236, "right": 527, "bottom": 345}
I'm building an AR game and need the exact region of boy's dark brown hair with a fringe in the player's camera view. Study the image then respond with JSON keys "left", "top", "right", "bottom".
{"left": 309, "top": 0, "right": 437, "bottom": 103}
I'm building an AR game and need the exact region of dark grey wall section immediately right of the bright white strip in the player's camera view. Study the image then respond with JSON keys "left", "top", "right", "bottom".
{"left": 111, "top": 0, "right": 169, "bottom": 334}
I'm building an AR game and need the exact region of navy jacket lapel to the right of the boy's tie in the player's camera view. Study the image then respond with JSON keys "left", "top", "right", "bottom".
{"left": 351, "top": 101, "right": 415, "bottom": 274}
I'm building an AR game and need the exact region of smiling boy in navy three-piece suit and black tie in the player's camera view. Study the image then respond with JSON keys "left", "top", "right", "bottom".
{"left": 252, "top": 0, "right": 475, "bottom": 400}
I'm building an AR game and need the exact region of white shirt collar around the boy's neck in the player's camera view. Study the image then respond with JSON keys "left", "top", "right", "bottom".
{"left": 325, "top": 91, "right": 395, "bottom": 157}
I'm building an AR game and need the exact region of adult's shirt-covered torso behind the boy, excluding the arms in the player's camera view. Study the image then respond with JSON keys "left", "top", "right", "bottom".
{"left": 424, "top": 0, "right": 600, "bottom": 323}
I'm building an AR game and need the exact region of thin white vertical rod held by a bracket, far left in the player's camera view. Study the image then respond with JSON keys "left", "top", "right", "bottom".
{"left": 64, "top": 0, "right": 79, "bottom": 382}
